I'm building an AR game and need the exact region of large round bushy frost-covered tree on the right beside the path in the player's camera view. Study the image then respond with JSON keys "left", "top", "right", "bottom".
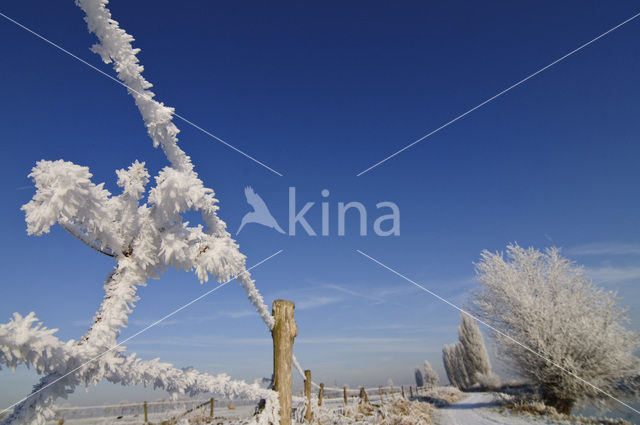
{"left": 473, "top": 245, "right": 640, "bottom": 413}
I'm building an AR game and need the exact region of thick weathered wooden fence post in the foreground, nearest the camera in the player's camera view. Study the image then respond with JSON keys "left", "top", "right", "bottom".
{"left": 271, "top": 300, "right": 298, "bottom": 425}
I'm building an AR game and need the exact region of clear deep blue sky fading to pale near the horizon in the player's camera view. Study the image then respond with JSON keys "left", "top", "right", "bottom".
{"left": 0, "top": 0, "right": 640, "bottom": 412}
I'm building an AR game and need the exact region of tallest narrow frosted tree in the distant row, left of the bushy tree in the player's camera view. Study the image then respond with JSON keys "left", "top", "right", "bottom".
{"left": 458, "top": 313, "right": 491, "bottom": 382}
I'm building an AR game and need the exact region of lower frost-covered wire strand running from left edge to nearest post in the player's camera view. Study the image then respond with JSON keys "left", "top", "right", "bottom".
{"left": 0, "top": 313, "right": 278, "bottom": 424}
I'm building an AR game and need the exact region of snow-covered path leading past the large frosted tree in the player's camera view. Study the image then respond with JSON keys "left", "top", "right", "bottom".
{"left": 435, "top": 393, "right": 552, "bottom": 425}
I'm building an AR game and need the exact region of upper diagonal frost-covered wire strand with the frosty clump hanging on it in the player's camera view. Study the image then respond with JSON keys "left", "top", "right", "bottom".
{"left": 76, "top": 0, "right": 273, "bottom": 322}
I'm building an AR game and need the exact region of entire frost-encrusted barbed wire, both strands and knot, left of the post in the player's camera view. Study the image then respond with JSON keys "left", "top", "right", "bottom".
{"left": 0, "top": 0, "right": 278, "bottom": 424}
